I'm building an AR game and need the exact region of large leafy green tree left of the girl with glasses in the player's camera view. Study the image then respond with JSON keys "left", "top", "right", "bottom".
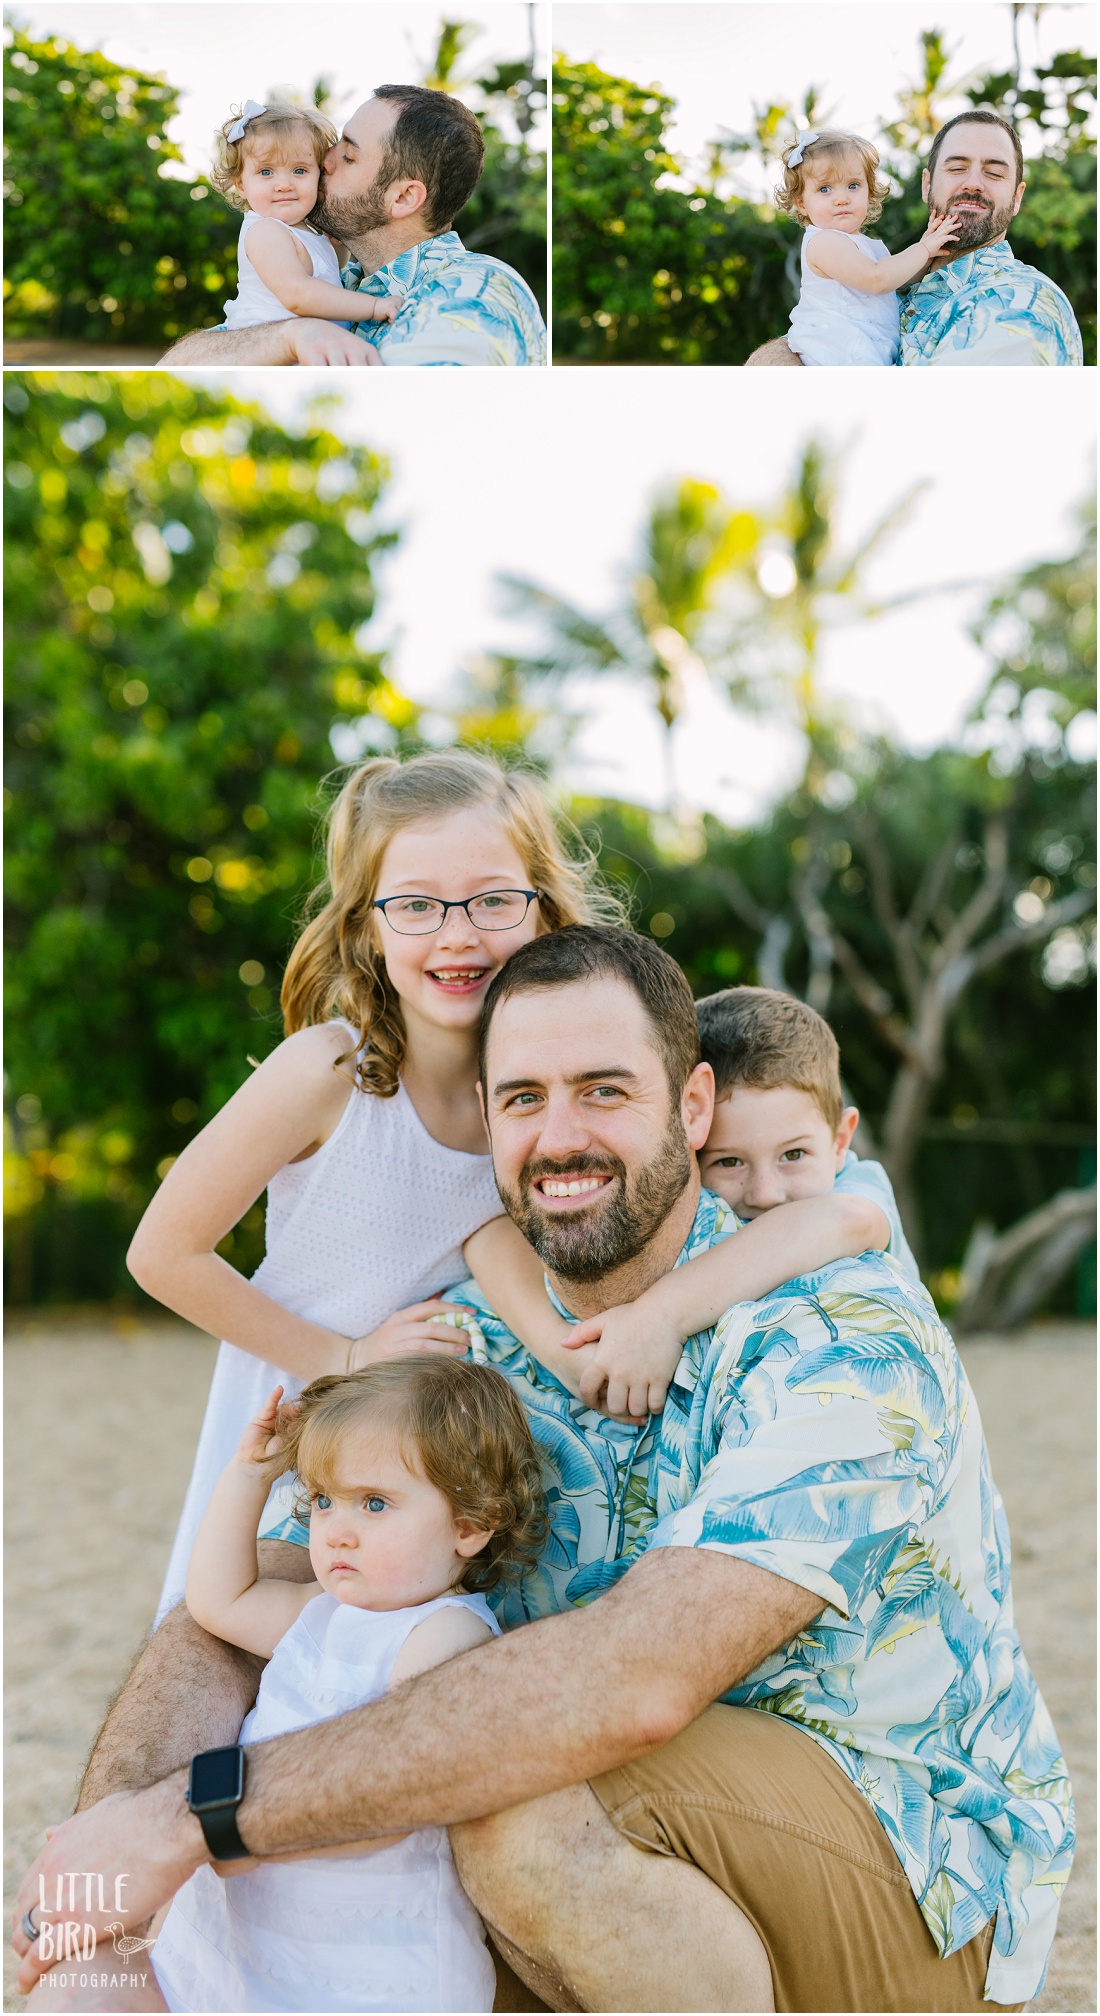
{"left": 4, "top": 373, "right": 402, "bottom": 1294}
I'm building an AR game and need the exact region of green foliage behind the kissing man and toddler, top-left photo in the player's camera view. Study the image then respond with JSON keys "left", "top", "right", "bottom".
{"left": 4, "top": 20, "right": 546, "bottom": 345}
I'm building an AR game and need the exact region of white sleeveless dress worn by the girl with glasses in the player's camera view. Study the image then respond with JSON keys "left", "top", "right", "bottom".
{"left": 157, "top": 1022, "right": 504, "bottom": 1623}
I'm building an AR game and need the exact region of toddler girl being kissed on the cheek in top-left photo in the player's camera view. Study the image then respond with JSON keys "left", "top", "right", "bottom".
{"left": 210, "top": 99, "right": 397, "bottom": 329}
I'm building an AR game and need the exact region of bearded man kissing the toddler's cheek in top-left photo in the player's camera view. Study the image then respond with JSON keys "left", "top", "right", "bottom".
{"left": 161, "top": 85, "right": 546, "bottom": 365}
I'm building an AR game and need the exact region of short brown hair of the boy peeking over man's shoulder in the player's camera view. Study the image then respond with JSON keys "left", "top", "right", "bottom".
{"left": 695, "top": 988, "right": 844, "bottom": 1131}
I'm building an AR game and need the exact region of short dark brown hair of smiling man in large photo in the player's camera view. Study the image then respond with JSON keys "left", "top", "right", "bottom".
{"left": 477, "top": 923, "right": 699, "bottom": 1101}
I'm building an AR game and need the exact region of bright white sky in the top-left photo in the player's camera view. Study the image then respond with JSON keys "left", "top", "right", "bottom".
{"left": 8, "top": 0, "right": 544, "bottom": 175}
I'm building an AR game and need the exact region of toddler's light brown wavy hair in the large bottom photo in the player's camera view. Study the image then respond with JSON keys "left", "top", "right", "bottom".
{"left": 268, "top": 1351, "right": 548, "bottom": 1595}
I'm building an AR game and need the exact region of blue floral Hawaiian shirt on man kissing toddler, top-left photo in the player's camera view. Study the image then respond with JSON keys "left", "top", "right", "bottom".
{"left": 342, "top": 232, "right": 546, "bottom": 365}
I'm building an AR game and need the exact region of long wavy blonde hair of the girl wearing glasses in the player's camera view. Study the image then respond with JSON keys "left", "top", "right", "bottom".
{"left": 282, "top": 750, "right": 627, "bottom": 1099}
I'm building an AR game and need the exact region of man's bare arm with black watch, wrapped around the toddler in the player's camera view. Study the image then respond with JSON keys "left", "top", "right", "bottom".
{"left": 12, "top": 1548, "right": 822, "bottom": 1988}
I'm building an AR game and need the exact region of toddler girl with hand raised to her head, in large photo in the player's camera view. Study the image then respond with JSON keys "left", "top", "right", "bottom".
{"left": 151, "top": 1357, "right": 546, "bottom": 2010}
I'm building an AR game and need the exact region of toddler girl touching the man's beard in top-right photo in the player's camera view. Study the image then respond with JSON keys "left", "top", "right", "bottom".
{"left": 776, "top": 133, "right": 959, "bottom": 365}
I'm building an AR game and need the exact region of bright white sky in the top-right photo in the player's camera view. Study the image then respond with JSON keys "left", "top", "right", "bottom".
{"left": 554, "top": 0, "right": 1096, "bottom": 194}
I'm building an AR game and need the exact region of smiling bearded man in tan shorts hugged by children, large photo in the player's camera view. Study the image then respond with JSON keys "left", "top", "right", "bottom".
{"left": 14, "top": 925, "right": 1072, "bottom": 2016}
